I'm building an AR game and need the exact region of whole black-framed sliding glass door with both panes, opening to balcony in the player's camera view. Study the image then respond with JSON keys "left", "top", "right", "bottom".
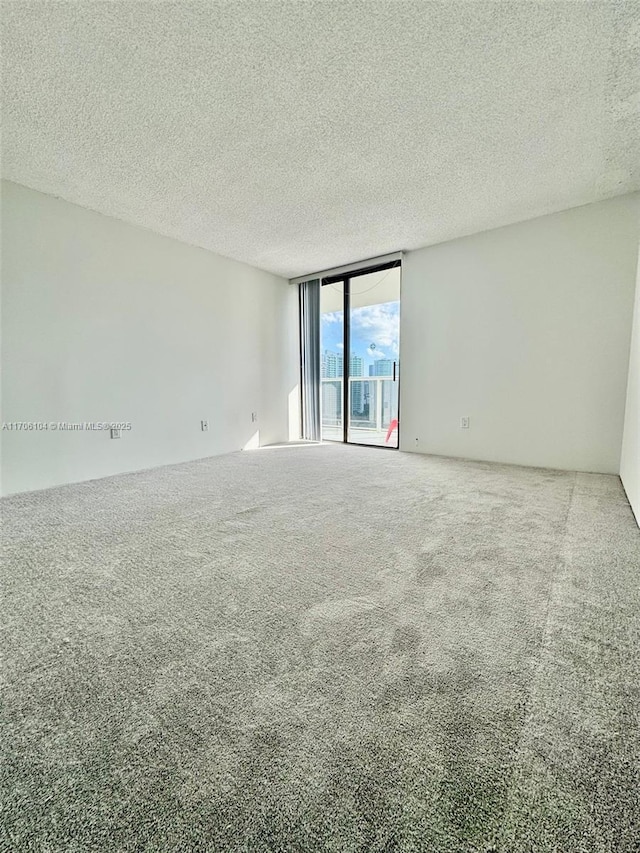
{"left": 320, "top": 262, "right": 400, "bottom": 448}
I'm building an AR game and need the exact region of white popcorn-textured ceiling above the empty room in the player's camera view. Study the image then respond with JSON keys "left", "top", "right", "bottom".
{"left": 2, "top": 0, "right": 640, "bottom": 276}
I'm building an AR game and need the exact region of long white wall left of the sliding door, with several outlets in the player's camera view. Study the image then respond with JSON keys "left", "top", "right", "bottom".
{"left": 2, "top": 182, "right": 297, "bottom": 494}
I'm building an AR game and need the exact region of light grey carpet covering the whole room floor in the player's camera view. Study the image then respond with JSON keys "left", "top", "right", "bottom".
{"left": 0, "top": 446, "right": 640, "bottom": 853}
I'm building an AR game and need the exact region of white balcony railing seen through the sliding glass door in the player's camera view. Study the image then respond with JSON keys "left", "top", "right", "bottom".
{"left": 321, "top": 376, "right": 398, "bottom": 447}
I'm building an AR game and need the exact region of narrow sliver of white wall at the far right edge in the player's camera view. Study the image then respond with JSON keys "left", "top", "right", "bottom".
{"left": 620, "top": 236, "right": 640, "bottom": 525}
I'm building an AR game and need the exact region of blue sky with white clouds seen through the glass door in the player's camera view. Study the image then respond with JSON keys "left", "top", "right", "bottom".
{"left": 320, "top": 302, "right": 400, "bottom": 365}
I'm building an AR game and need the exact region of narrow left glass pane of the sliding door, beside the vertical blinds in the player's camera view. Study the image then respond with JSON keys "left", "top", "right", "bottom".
{"left": 320, "top": 281, "right": 345, "bottom": 441}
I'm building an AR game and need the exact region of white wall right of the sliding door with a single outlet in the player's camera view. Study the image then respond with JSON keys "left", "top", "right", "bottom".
{"left": 400, "top": 193, "right": 640, "bottom": 474}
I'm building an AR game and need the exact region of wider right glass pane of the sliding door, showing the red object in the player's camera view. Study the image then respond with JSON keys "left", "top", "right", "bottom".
{"left": 348, "top": 267, "right": 400, "bottom": 448}
